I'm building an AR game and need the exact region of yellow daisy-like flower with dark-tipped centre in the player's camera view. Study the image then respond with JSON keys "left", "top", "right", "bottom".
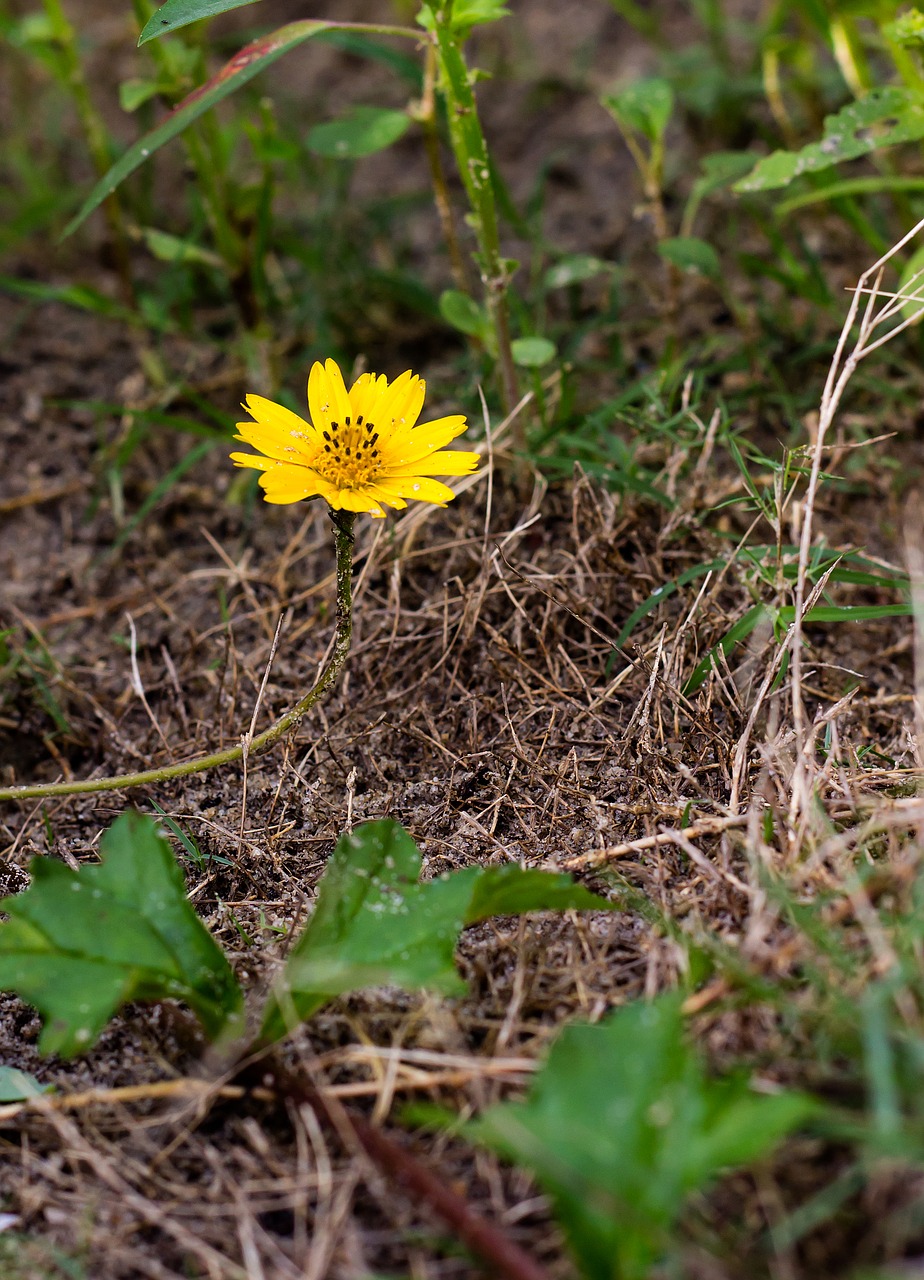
{"left": 230, "top": 360, "right": 479, "bottom": 517}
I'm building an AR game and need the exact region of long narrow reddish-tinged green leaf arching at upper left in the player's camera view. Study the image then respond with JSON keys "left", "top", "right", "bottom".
{"left": 63, "top": 20, "right": 333, "bottom": 238}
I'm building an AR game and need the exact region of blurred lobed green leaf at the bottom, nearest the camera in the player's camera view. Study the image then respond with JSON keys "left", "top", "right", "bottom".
{"left": 466, "top": 995, "right": 816, "bottom": 1280}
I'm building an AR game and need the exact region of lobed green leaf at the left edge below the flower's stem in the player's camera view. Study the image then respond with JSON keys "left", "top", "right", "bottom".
{"left": 0, "top": 813, "right": 243, "bottom": 1057}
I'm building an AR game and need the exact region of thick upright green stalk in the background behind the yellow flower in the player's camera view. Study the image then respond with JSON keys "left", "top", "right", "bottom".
{"left": 430, "top": 5, "right": 517, "bottom": 440}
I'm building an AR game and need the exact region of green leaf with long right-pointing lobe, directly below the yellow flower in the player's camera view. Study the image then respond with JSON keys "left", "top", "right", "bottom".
{"left": 260, "top": 818, "right": 613, "bottom": 1042}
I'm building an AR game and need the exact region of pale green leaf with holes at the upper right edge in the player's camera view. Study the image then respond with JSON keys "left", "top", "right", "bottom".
{"left": 735, "top": 86, "right": 924, "bottom": 192}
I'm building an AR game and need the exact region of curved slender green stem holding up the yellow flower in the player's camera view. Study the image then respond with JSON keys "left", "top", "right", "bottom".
{"left": 0, "top": 511, "right": 356, "bottom": 800}
